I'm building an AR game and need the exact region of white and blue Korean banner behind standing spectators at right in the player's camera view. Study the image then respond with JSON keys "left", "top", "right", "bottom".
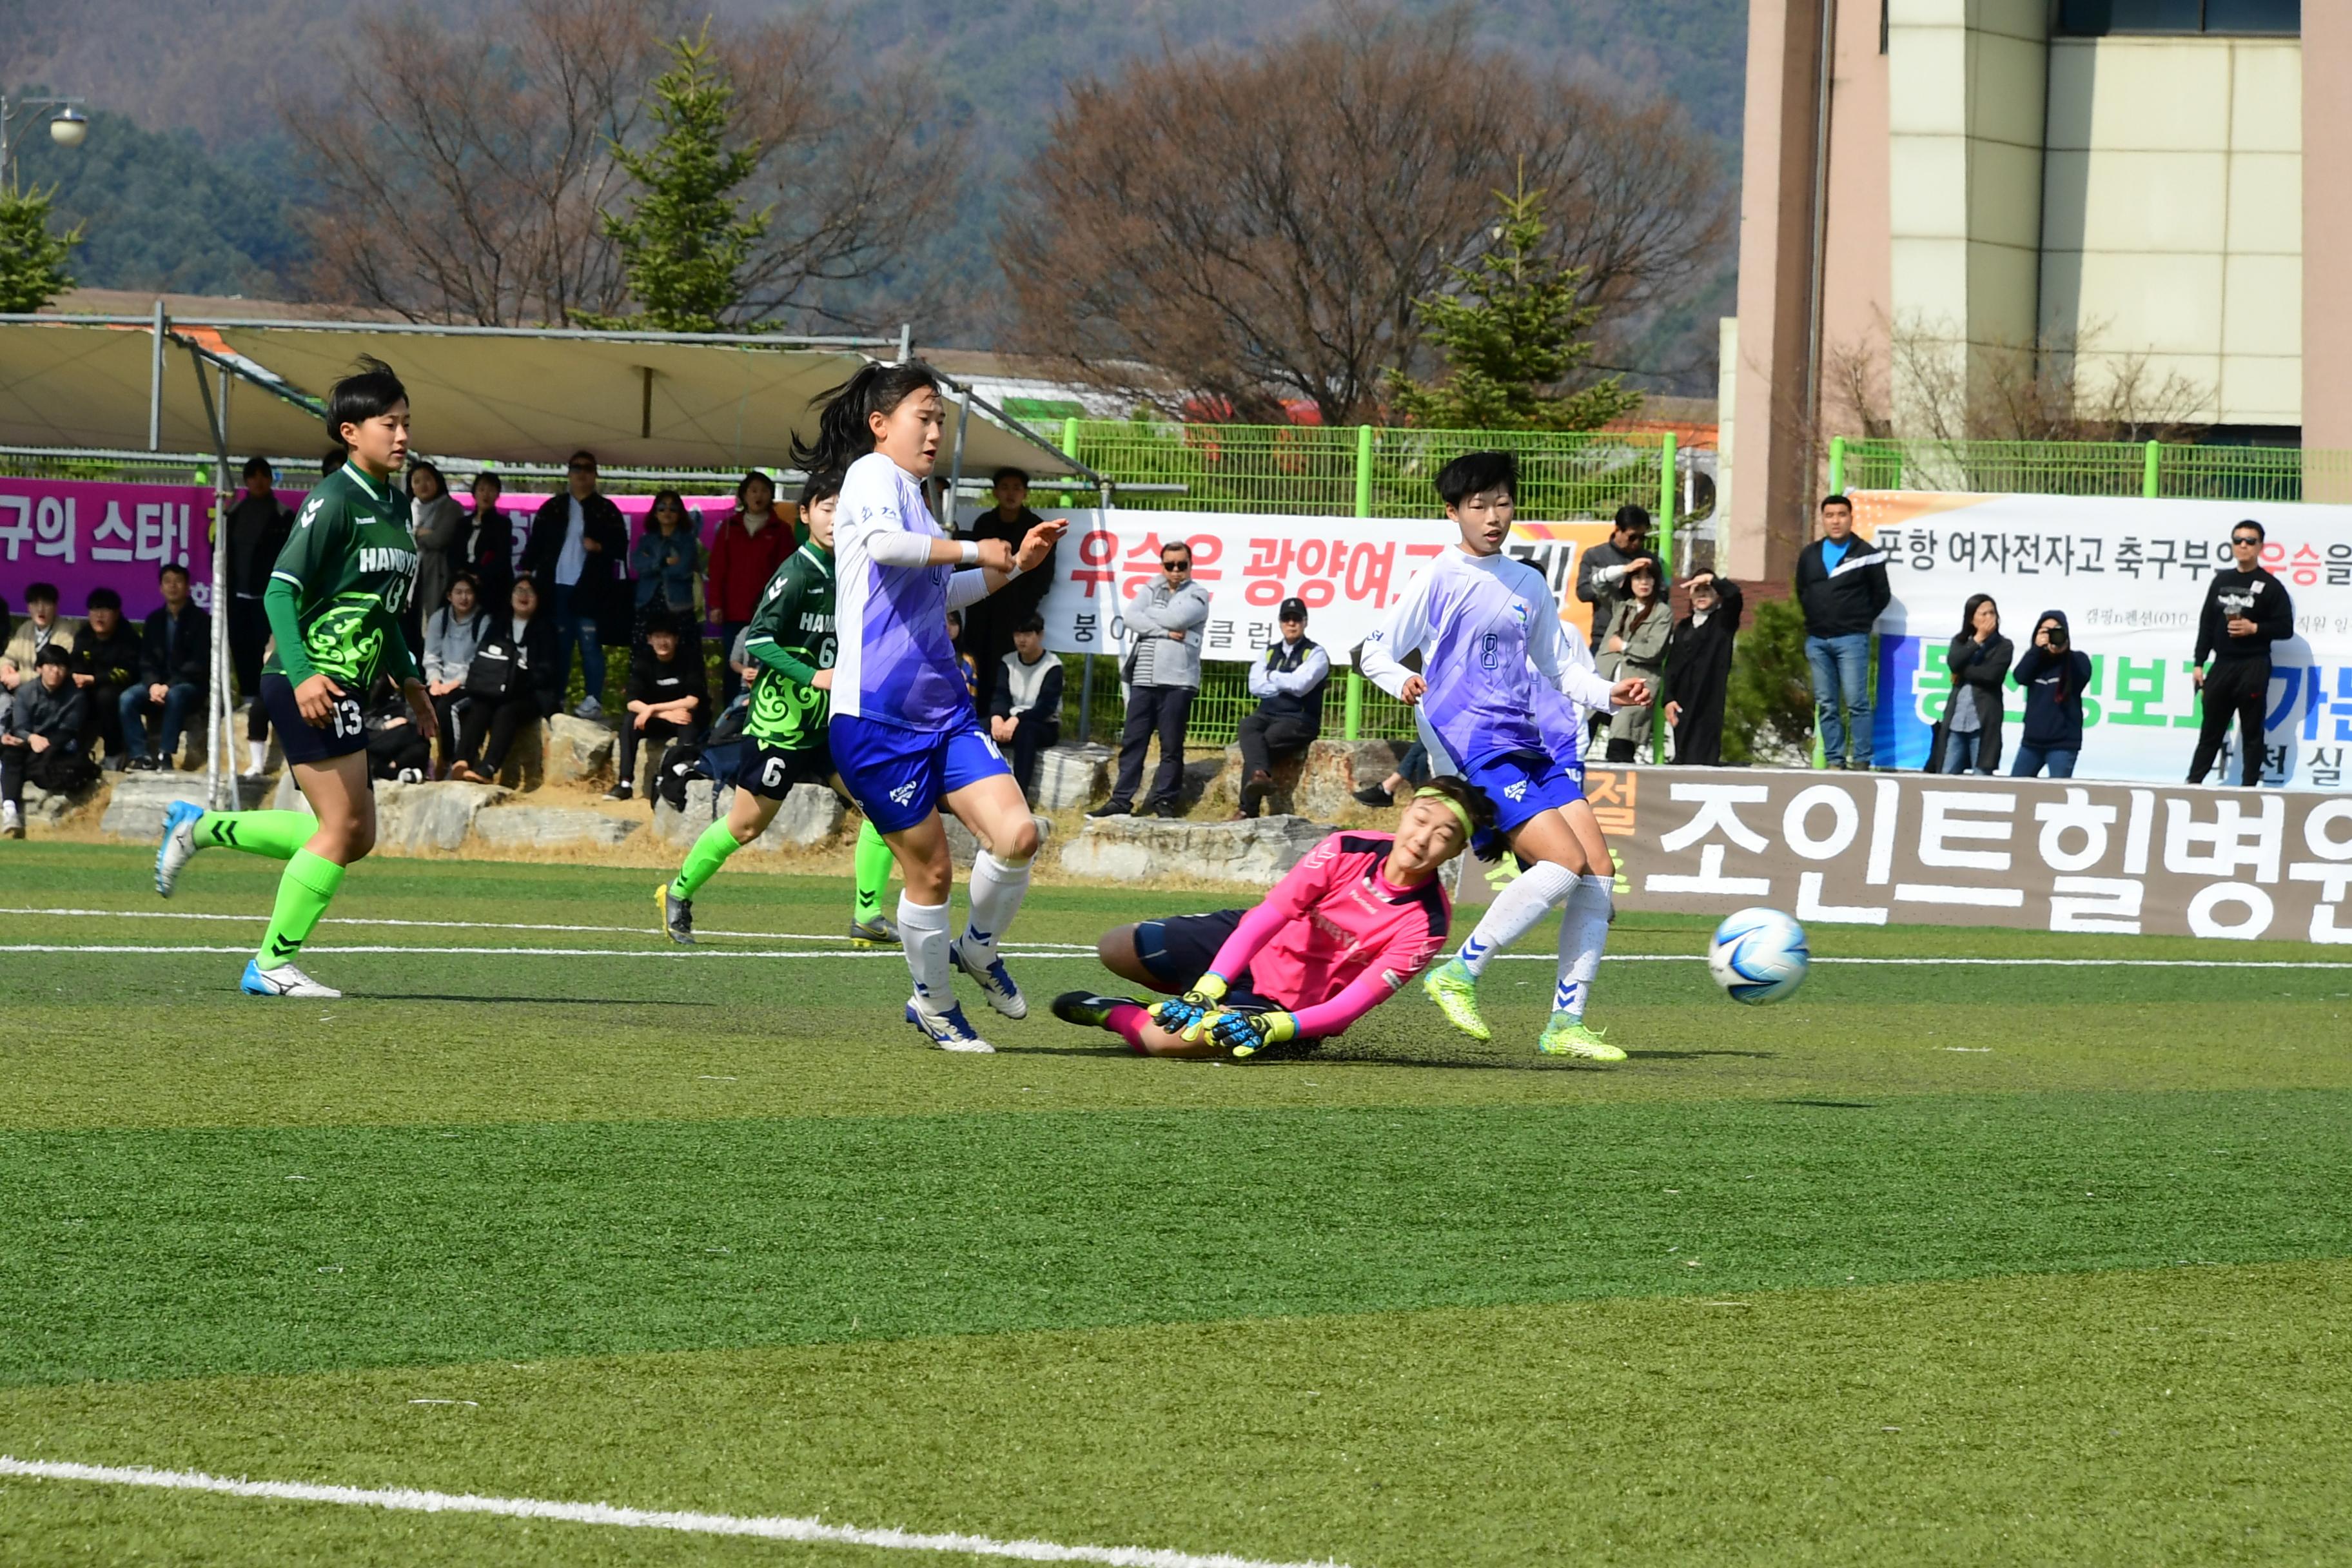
{"left": 1854, "top": 491, "right": 2352, "bottom": 790}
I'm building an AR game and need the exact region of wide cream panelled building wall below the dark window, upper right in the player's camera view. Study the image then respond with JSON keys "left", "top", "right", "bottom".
{"left": 2041, "top": 36, "right": 2295, "bottom": 426}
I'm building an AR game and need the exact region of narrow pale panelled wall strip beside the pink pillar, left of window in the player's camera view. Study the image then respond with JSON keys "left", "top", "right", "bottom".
{"left": 1886, "top": 0, "right": 2048, "bottom": 433}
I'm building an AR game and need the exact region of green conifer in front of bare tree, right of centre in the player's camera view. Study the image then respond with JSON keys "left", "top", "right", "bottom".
{"left": 1390, "top": 181, "right": 1642, "bottom": 430}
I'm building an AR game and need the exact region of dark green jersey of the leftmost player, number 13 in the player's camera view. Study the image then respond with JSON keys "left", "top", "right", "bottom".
{"left": 261, "top": 463, "right": 416, "bottom": 698}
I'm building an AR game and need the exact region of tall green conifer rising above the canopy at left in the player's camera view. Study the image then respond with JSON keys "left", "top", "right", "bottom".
{"left": 581, "top": 21, "right": 769, "bottom": 331}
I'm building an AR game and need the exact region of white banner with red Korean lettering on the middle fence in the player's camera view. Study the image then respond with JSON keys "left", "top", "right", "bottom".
{"left": 1042, "top": 508, "right": 1609, "bottom": 661}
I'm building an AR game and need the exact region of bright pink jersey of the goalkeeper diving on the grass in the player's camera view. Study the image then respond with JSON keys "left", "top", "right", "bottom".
{"left": 1213, "top": 832, "right": 1453, "bottom": 1037}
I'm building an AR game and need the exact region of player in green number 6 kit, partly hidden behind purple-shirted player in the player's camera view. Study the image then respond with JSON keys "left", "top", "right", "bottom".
{"left": 654, "top": 473, "right": 899, "bottom": 947}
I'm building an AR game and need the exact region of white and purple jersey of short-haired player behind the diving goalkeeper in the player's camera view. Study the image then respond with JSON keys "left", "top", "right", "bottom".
{"left": 1362, "top": 548, "right": 1611, "bottom": 769}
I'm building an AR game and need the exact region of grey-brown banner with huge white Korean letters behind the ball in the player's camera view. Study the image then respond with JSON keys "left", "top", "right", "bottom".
{"left": 1585, "top": 769, "right": 2352, "bottom": 943}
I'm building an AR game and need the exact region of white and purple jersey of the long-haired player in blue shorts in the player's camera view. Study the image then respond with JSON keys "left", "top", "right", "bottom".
{"left": 832, "top": 451, "right": 988, "bottom": 731}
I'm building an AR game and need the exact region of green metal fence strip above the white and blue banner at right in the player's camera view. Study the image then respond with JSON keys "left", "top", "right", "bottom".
{"left": 1830, "top": 435, "right": 2352, "bottom": 501}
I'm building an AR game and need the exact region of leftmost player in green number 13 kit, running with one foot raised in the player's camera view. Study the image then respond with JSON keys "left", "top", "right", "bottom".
{"left": 155, "top": 360, "right": 435, "bottom": 997}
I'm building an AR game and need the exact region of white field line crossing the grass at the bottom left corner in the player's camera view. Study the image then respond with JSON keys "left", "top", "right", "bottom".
{"left": 0, "top": 1455, "right": 1338, "bottom": 1568}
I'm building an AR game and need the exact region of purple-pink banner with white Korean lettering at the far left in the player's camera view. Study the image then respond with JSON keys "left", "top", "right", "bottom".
{"left": 0, "top": 477, "right": 211, "bottom": 621}
